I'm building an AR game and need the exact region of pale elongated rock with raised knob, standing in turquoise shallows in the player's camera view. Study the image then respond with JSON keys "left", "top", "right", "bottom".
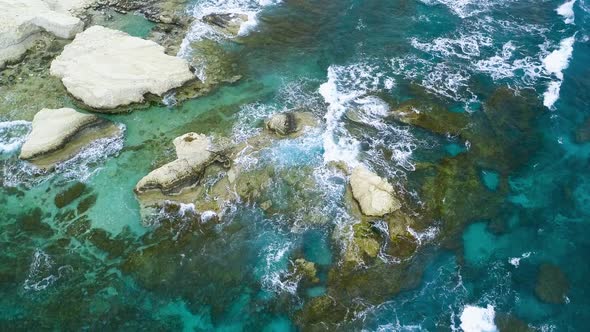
{"left": 135, "top": 133, "right": 216, "bottom": 194}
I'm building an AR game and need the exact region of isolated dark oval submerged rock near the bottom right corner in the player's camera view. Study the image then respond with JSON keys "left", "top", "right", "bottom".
{"left": 535, "top": 263, "right": 569, "bottom": 304}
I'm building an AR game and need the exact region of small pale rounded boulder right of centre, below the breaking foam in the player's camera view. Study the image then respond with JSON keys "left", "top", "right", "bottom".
{"left": 350, "top": 166, "right": 401, "bottom": 217}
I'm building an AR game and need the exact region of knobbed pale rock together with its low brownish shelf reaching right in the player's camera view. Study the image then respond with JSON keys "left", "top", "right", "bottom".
{"left": 135, "top": 111, "right": 317, "bottom": 214}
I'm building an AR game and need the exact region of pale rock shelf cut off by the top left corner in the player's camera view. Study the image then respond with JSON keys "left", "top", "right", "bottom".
{"left": 0, "top": 0, "right": 88, "bottom": 68}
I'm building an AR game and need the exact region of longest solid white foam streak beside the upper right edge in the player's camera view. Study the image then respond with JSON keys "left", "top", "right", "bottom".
{"left": 543, "top": 35, "right": 576, "bottom": 108}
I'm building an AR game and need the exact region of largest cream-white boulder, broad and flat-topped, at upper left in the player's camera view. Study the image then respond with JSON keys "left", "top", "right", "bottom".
{"left": 50, "top": 26, "right": 195, "bottom": 109}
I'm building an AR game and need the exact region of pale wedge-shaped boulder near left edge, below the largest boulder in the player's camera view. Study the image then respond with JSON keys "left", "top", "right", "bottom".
{"left": 20, "top": 108, "right": 104, "bottom": 159}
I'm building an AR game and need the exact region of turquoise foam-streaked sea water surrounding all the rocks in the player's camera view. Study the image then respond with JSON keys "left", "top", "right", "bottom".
{"left": 0, "top": 0, "right": 590, "bottom": 331}
